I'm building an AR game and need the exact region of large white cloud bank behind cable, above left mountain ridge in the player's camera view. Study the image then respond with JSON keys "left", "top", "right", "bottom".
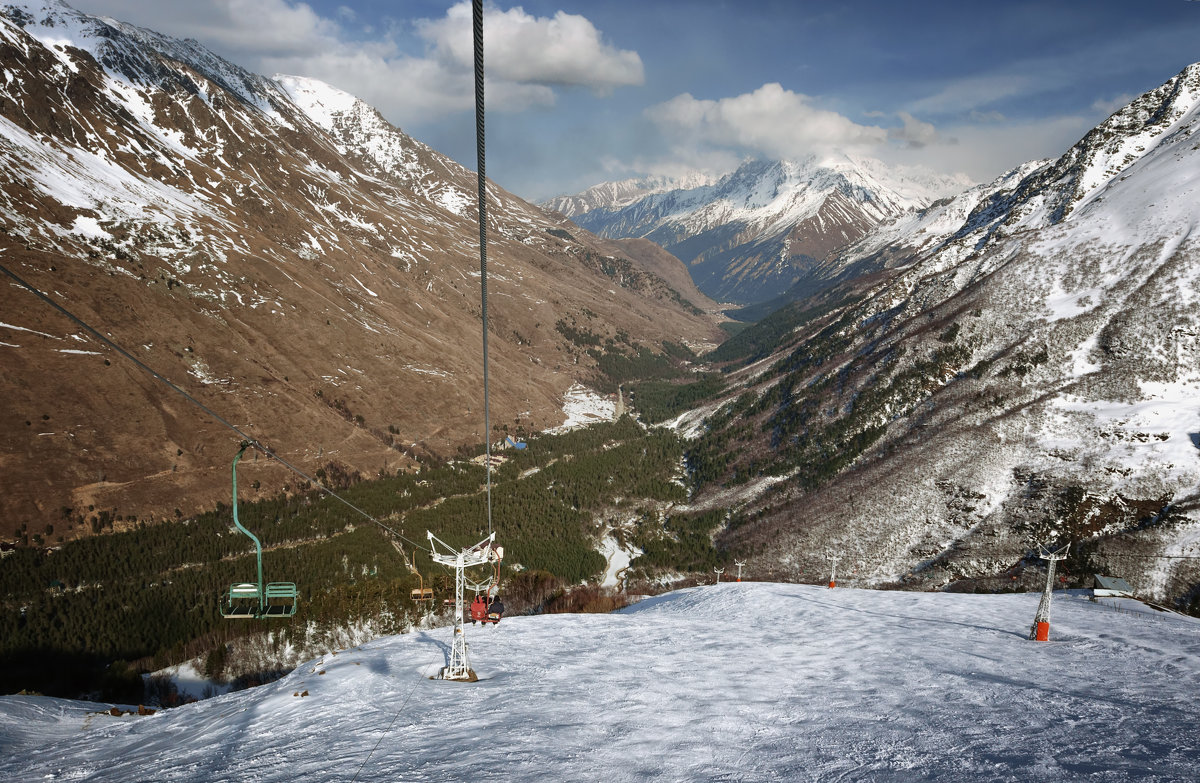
{"left": 74, "top": 0, "right": 644, "bottom": 126}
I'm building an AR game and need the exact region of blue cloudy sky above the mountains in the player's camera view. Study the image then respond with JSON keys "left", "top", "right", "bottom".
{"left": 67, "top": 0, "right": 1200, "bottom": 201}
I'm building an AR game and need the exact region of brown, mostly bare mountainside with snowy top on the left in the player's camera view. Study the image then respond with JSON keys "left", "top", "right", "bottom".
{"left": 0, "top": 1, "right": 720, "bottom": 534}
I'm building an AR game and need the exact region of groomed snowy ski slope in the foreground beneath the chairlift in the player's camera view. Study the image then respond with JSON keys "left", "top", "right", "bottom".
{"left": 0, "top": 582, "right": 1200, "bottom": 783}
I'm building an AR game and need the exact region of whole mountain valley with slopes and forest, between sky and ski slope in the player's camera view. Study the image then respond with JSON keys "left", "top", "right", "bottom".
{"left": 0, "top": 0, "right": 1200, "bottom": 692}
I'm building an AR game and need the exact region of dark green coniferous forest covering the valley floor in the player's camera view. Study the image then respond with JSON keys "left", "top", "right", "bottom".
{"left": 0, "top": 417, "right": 725, "bottom": 701}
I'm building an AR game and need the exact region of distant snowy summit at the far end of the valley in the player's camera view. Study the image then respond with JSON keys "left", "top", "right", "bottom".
{"left": 542, "top": 155, "right": 971, "bottom": 304}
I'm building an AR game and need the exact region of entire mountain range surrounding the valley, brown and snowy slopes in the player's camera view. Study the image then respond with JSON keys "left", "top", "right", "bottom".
{"left": 0, "top": 0, "right": 1200, "bottom": 612}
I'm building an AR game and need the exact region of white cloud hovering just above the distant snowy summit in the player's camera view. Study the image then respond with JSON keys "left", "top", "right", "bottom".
{"left": 646, "top": 83, "right": 888, "bottom": 159}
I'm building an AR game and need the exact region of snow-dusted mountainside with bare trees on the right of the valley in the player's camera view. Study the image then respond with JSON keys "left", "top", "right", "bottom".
{"left": 698, "top": 65, "right": 1200, "bottom": 604}
